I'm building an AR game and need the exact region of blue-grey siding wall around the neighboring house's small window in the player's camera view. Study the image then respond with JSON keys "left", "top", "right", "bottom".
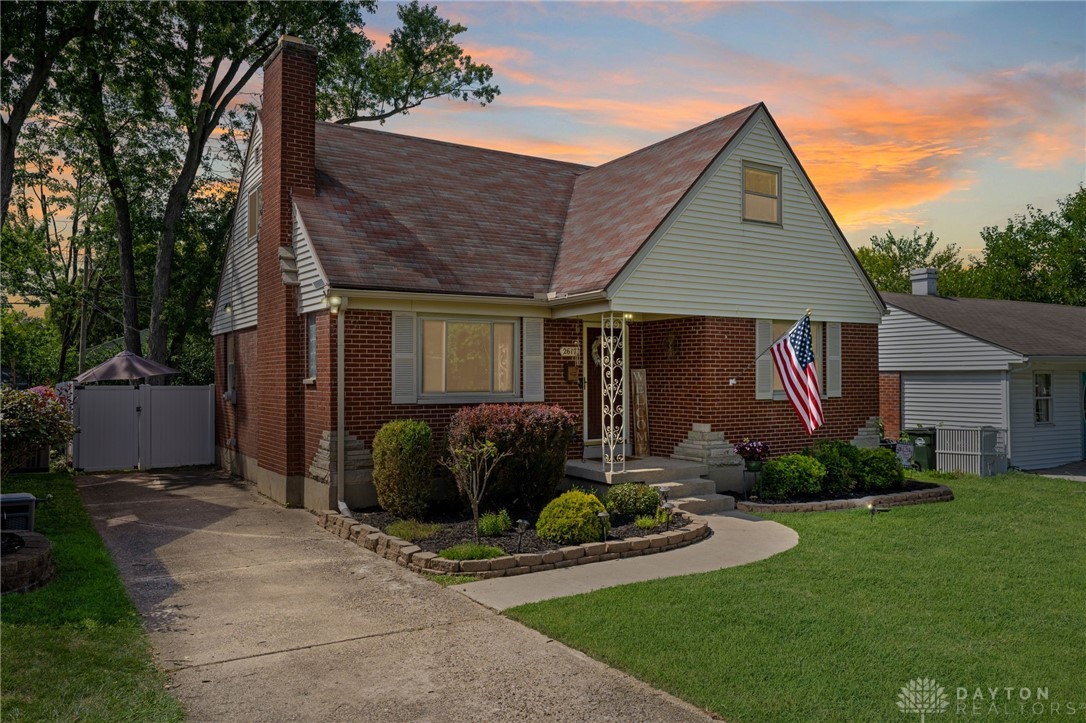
{"left": 1010, "top": 365, "right": 1083, "bottom": 469}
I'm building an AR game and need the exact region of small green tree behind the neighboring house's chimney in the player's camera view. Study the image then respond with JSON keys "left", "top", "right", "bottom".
{"left": 856, "top": 228, "right": 975, "bottom": 296}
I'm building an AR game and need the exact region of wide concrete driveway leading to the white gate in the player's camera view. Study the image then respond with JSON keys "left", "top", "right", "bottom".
{"left": 77, "top": 470, "right": 709, "bottom": 722}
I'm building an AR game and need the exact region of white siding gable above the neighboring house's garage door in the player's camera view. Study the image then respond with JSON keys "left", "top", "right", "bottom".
{"left": 879, "top": 306, "right": 1022, "bottom": 371}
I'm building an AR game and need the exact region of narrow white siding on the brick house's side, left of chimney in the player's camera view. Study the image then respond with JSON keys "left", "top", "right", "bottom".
{"left": 211, "top": 123, "right": 261, "bottom": 334}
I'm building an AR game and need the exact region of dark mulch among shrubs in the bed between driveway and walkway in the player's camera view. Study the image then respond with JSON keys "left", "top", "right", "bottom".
{"left": 354, "top": 503, "right": 687, "bottom": 555}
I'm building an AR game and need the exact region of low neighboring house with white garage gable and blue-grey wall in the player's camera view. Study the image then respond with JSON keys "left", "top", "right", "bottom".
{"left": 879, "top": 268, "right": 1086, "bottom": 469}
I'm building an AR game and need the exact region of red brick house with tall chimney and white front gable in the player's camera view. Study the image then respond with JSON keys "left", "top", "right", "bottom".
{"left": 212, "top": 38, "right": 885, "bottom": 508}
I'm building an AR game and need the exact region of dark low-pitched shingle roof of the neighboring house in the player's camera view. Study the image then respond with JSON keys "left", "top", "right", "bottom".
{"left": 882, "top": 292, "right": 1086, "bottom": 357}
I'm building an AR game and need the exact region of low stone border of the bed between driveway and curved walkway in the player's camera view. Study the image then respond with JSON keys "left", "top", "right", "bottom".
{"left": 317, "top": 509, "right": 709, "bottom": 579}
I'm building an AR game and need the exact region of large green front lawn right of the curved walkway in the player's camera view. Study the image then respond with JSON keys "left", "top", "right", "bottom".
{"left": 508, "top": 473, "right": 1086, "bottom": 721}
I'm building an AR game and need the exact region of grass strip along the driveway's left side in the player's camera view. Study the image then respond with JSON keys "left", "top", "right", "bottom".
{"left": 0, "top": 474, "right": 185, "bottom": 721}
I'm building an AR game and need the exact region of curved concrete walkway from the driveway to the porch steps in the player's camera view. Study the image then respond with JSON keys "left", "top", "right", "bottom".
{"left": 451, "top": 512, "right": 799, "bottom": 610}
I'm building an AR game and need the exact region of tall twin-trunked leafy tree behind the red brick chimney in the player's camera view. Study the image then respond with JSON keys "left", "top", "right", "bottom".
{"left": 58, "top": 0, "right": 498, "bottom": 362}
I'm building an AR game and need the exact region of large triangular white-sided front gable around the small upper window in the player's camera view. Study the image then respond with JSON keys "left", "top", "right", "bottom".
{"left": 613, "top": 113, "right": 882, "bottom": 324}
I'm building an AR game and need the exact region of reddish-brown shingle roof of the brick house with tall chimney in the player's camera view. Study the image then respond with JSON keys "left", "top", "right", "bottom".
{"left": 294, "top": 105, "right": 759, "bottom": 297}
